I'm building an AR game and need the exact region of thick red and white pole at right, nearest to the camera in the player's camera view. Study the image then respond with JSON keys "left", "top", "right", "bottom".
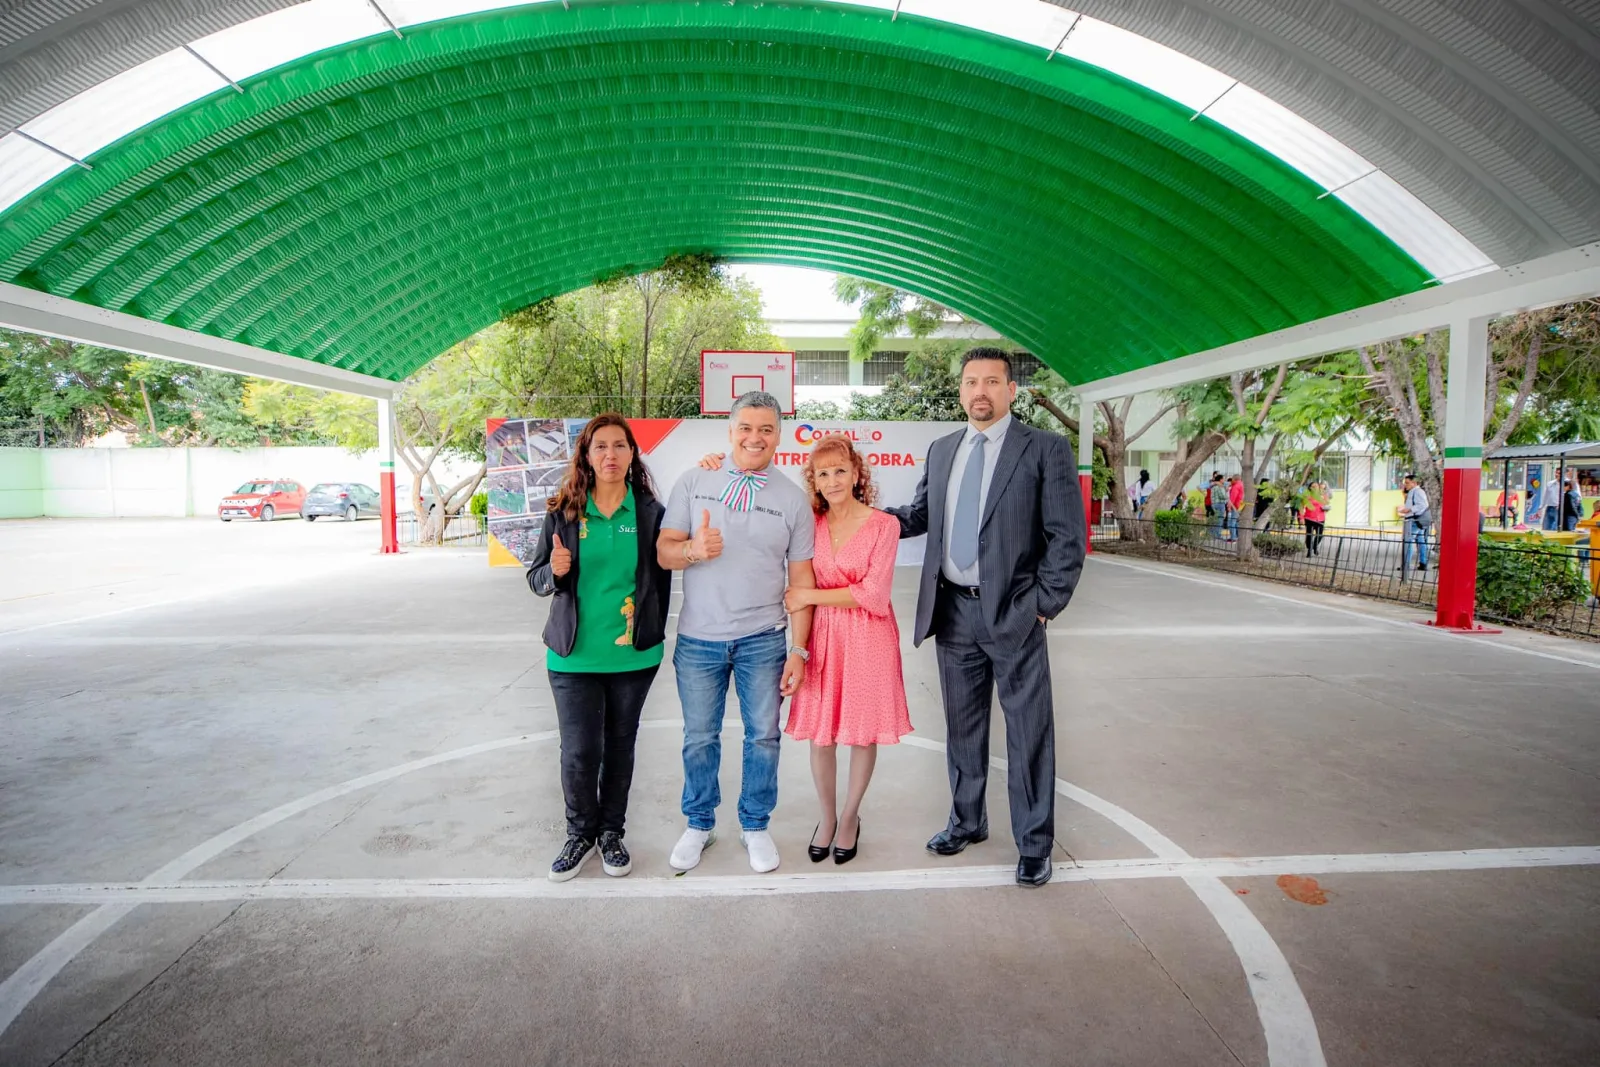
{"left": 1434, "top": 318, "right": 1490, "bottom": 630}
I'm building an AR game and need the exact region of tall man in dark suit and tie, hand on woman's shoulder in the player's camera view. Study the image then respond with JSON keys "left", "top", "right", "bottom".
{"left": 886, "top": 349, "right": 1088, "bottom": 886}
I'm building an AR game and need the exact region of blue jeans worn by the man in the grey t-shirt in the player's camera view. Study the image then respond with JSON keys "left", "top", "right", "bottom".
{"left": 672, "top": 627, "right": 789, "bottom": 830}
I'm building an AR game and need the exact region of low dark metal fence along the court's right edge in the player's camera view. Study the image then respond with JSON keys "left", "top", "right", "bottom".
{"left": 1096, "top": 518, "right": 1600, "bottom": 637}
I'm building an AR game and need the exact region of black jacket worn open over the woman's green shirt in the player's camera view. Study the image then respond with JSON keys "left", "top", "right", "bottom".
{"left": 528, "top": 485, "right": 672, "bottom": 656}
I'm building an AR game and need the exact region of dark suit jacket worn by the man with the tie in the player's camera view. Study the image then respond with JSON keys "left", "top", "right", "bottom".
{"left": 885, "top": 419, "right": 1088, "bottom": 645}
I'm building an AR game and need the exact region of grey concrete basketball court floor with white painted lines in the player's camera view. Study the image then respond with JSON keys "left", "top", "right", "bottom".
{"left": 0, "top": 522, "right": 1600, "bottom": 1067}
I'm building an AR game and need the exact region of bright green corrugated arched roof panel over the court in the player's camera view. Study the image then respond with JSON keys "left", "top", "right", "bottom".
{"left": 0, "top": 0, "right": 1427, "bottom": 382}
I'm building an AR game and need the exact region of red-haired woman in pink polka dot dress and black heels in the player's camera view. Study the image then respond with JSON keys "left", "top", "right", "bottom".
{"left": 784, "top": 437, "right": 910, "bottom": 864}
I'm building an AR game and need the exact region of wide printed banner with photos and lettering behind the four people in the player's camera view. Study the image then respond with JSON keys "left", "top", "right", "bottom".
{"left": 486, "top": 419, "right": 965, "bottom": 566}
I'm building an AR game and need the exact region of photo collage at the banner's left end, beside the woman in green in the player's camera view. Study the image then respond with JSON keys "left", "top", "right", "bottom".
{"left": 485, "top": 419, "right": 589, "bottom": 563}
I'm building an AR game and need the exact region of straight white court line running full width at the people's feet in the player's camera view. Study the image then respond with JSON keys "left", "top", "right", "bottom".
{"left": 0, "top": 845, "right": 1600, "bottom": 907}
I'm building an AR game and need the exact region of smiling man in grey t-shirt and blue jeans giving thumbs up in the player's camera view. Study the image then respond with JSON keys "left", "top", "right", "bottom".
{"left": 656, "top": 392, "right": 816, "bottom": 872}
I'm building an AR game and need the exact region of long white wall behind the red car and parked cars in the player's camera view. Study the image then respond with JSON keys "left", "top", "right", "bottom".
{"left": 12, "top": 448, "right": 477, "bottom": 518}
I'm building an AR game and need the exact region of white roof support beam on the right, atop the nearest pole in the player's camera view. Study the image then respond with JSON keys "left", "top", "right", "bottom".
{"left": 1078, "top": 242, "right": 1600, "bottom": 400}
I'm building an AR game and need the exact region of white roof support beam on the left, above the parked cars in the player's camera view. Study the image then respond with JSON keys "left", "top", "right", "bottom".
{"left": 0, "top": 282, "right": 398, "bottom": 400}
